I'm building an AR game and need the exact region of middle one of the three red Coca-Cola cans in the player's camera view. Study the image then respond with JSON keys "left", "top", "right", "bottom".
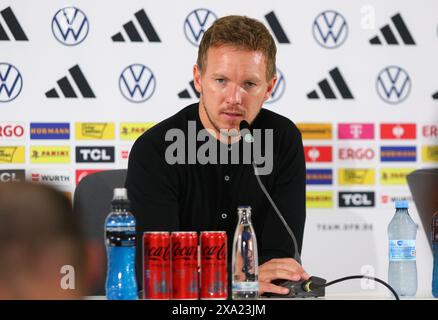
{"left": 170, "top": 231, "right": 198, "bottom": 300}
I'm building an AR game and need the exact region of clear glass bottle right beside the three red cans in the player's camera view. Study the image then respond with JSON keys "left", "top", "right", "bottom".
{"left": 231, "top": 206, "right": 259, "bottom": 299}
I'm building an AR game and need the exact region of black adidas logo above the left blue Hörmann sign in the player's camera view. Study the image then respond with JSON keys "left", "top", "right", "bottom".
{"left": 46, "top": 65, "right": 96, "bottom": 98}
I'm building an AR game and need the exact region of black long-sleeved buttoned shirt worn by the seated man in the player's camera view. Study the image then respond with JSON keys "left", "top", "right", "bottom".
{"left": 126, "top": 103, "right": 306, "bottom": 283}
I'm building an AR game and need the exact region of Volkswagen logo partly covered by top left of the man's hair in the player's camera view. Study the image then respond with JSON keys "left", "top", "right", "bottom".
{"left": 184, "top": 9, "right": 217, "bottom": 47}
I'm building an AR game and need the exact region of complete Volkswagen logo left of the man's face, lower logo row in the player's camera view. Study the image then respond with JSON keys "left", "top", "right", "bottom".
{"left": 119, "top": 64, "right": 156, "bottom": 103}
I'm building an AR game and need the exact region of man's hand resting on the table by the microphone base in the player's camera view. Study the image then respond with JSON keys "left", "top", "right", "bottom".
{"left": 259, "top": 258, "right": 310, "bottom": 294}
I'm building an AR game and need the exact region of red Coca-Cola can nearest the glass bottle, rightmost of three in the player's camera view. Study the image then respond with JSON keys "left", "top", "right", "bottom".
{"left": 200, "top": 231, "right": 228, "bottom": 300}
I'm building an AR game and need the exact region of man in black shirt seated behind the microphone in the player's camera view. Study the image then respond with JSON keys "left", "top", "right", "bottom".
{"left": 126, "top": 16, "right": 309, "bottom": 294}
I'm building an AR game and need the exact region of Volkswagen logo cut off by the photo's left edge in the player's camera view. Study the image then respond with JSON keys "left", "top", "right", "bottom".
{"left": 0, "top": 63, "right": 23, "bottom": 102}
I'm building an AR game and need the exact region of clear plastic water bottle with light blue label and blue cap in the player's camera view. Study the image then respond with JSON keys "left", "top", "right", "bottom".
{"left": 388, "top": 201, "right": 417, "bottom": 296}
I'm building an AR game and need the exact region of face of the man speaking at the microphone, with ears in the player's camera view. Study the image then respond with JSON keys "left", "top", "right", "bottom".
{"left": 193, "top": 46, "right": 277, "bottom": 132}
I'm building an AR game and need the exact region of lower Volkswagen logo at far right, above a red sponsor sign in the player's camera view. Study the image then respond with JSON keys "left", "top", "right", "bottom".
{"left": 376, "top": 66, "right": 411, "bottom": 104}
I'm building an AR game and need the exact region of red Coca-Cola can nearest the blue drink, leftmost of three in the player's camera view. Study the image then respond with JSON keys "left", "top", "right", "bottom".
{"left": 143, "top": 232, "right": 171, "bottom": 300}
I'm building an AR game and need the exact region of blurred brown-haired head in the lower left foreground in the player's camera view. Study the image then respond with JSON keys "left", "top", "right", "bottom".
{"left": 0, "top": 182, "right": 96, "bottom": 300}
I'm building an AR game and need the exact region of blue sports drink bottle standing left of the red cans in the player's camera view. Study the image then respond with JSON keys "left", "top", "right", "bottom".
{"left": 105, "top": 188, "right": 137, "bottom": 300}
